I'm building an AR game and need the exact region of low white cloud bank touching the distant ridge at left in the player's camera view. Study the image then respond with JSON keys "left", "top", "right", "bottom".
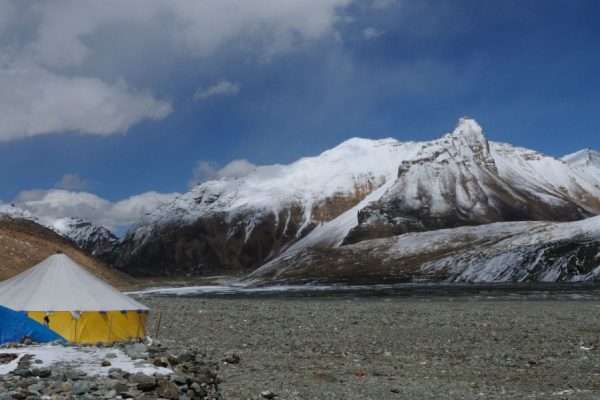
{"left": 14, "top": 189, "right": 179, "bottom": 229}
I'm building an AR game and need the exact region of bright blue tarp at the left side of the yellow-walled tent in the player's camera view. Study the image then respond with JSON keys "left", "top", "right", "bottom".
{"left": 0, "top": 306, "right": 65, "bottom": 344}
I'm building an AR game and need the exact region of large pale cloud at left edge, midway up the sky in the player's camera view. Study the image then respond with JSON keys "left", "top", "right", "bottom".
{"left": 0, "top": 66, "right": 171, "bottom": 142}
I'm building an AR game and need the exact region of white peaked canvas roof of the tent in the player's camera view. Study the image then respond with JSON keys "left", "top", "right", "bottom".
{"left": 0, "top": 254, "right": 148, "bottom": 311}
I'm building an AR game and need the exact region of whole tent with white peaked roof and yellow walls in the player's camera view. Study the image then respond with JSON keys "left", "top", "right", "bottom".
{"left": 0, "top": 254, "right": 148, "bottom": 343}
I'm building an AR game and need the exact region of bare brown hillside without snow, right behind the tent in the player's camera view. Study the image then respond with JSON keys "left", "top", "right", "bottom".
{"left": 0, "top": 213, "right": 133, "bottom": 289}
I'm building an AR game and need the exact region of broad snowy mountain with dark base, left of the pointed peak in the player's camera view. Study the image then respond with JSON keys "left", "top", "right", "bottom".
{"left": 113, "top": 139, "right": 415, "bottom": 274}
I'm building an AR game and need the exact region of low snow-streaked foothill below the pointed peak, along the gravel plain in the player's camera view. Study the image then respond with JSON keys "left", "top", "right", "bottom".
{"left": 248, "top": 217, "right": 600, "bottom": 285}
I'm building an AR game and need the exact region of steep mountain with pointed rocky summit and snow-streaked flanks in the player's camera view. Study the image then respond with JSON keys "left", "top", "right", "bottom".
{"left": 345, "top": 118, "right": 600, "bottom": 243}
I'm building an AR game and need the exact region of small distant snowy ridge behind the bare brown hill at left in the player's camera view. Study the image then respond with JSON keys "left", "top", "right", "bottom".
{"left": 0, "top": 204, "right": 118, "bottom": 261}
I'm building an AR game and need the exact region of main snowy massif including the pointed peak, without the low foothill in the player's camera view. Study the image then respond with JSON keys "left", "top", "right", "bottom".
{"left": 117, "top": 118, "right": 600, "bottom": 274}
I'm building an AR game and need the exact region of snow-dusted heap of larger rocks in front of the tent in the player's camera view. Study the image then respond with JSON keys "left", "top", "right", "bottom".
{"left": 0, "top": 339, "right": 220, "bottom": 400}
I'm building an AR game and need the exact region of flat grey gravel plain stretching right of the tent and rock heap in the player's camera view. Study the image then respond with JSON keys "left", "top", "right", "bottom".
{"left": 143, "top": 298, "right": 600, "bottom": 399}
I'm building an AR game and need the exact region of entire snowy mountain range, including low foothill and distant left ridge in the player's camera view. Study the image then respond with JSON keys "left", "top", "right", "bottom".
{"left": 0, "top": 118, "right": 600, "bottom": 282}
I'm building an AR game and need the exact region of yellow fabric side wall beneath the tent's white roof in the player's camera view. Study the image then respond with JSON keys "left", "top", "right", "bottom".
{"left": 27, "top": 311, "right": 148, "bottom": 343}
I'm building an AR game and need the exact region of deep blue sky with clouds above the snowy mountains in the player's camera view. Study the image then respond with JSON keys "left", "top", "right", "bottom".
{"left": 0, "top": 0, "right": 600, "bottom": 230}
